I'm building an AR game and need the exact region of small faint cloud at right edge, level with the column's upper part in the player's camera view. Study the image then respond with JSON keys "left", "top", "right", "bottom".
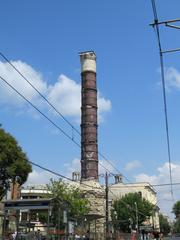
{"left": 165, "top": 67, "right": 180, "bottom": 90}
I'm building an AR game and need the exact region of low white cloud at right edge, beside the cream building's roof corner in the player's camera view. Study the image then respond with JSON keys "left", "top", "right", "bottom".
{"left": 135, "top": 162, "right": 180, "bottom": 218}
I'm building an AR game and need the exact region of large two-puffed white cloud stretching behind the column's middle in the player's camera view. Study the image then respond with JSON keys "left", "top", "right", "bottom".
{"left": 0, "top": 61, "right": 111, "bottom": 119}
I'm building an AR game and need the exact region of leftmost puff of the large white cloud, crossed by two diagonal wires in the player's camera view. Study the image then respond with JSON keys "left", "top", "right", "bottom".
{"left": 0, "top": 61, "right": 47, "bottom": 106}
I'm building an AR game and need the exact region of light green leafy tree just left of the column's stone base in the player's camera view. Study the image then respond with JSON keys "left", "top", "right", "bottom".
{"left": 47, "top": 179, "right": 89, "bottom": 219}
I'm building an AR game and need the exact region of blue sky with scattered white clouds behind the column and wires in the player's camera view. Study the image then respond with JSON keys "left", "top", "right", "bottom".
{"left": 0, "top": 0, "right": 180, "bottom": 218}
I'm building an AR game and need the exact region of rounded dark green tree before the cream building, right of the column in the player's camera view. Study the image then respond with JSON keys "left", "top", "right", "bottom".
{"left": 111, "top": 193, "right": 154, "bottom": 231}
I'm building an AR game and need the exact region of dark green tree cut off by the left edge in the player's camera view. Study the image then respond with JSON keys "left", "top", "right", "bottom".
{"left": 0, "top": 128, "right": 32, "bottom": 200}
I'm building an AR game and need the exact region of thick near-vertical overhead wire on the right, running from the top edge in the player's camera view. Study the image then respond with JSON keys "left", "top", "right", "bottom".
{"left": 151, "top": 0, "right": 173, "bottom": 199}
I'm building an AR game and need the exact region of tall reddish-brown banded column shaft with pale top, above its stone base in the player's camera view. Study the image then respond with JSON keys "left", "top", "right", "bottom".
{"left": 80, "top": 51, "right": 98, "bottom": 180}
